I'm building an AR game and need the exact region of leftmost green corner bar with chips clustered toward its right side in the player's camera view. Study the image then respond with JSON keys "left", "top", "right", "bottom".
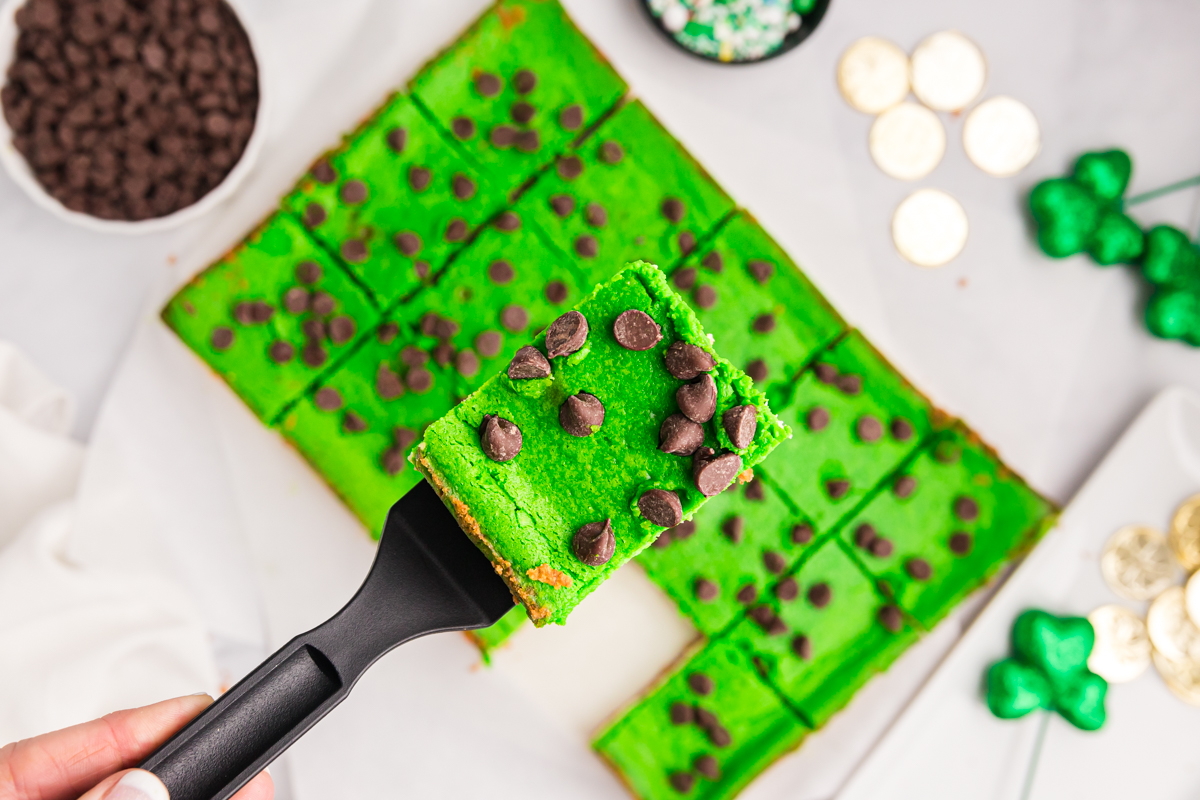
{"left": 162, "top": 213, "right": 379, "bottom": 422}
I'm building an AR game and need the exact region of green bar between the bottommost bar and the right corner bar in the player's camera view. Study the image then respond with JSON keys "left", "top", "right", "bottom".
{"left": 728, "top": 537, "right": 917, "bottom": 728}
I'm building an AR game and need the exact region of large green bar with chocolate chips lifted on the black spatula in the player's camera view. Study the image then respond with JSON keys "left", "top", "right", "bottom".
{"left": 413, "top": 263, "right": 790, "bottom": 625}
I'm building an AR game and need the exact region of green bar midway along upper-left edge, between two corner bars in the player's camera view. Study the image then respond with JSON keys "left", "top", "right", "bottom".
{"left": 283, "top": 95, "right": 504, "bottom": 306}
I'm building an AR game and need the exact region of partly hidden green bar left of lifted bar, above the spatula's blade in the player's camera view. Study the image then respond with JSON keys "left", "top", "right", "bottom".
{"left": 277, "top": 321, "right": 457, "bottom": 537}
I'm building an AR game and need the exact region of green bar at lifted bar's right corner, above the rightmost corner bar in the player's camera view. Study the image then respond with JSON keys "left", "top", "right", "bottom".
{"left": 763, "top": 331, "right": 940, "bottom": 534}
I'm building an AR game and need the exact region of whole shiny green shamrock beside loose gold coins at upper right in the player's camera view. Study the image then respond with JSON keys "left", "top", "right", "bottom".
{"left": 1030, "top": 150, "right": 1145, "bottom": 265}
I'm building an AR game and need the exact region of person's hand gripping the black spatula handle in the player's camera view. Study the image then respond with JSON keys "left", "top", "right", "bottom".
{"left": 0, "top": 694, "right": 275, "bottom": 800}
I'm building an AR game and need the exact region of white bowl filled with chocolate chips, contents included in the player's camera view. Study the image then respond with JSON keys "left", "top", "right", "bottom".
{"left": 0, "top": 0, "right": 265, "bottom": 233}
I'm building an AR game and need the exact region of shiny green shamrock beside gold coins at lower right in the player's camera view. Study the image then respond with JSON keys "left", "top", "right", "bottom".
{"left": 988, "top": 609, "right": 1109, "bottom": 730}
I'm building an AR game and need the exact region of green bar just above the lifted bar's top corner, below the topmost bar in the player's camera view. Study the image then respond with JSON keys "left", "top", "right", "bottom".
{"left": 517, "top": 101, "right": 733, "bottom": 282}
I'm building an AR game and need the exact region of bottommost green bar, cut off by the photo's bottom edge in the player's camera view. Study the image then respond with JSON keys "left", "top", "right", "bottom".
{"left": 593, "top": 642, "right": 809, "bottom": 800}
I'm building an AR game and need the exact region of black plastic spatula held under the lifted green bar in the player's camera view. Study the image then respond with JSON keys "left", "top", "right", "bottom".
{"left": 140, "top": 481, "right": 512, "bottom": 800}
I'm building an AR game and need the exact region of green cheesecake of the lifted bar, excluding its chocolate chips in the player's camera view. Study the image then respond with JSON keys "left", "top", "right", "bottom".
{"left": 415, "top": 263, "right": 788, "bottom": 625}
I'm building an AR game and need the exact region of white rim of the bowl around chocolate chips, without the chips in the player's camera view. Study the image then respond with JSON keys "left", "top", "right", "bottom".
{"left": 0, "top": 0, "right": 268, "bottom": 235}
